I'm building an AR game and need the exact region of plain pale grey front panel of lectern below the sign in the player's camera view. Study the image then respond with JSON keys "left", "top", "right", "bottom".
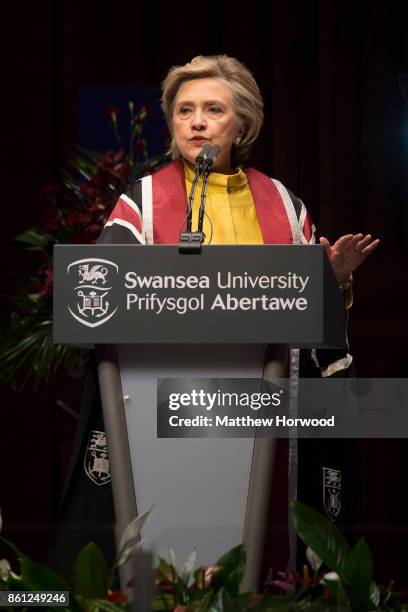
{"left": 119, "top": 345, "right": 264, "bottom": 564}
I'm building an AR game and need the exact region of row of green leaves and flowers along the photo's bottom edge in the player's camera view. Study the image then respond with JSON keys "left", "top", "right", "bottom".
{"left": 0, "top": 502, "right": 408, "bottom": 612}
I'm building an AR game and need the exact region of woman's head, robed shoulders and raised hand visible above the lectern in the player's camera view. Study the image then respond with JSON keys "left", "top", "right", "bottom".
{"left": 100, "top": 55, "right": 379, "bottom": 296}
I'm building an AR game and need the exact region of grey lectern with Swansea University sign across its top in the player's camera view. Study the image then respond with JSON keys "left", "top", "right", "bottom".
{"left": 54, "top": 245, "right": 345, "bottom": 589}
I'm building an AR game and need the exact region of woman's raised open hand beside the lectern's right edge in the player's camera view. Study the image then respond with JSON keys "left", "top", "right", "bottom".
{"left": 320, "top": 234, "right": 380, "bottom": 283}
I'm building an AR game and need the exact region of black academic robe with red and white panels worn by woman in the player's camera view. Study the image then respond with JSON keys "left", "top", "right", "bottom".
{"left": 48, "top": 161, "right": 352, "bottom": 573}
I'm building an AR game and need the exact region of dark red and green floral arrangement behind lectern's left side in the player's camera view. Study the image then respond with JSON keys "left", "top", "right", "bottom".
{"left": 0, "top": 101, "right": 165, "bottom": 388}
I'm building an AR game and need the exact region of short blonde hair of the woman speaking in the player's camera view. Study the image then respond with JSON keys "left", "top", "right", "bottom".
{"left": 161, "top": 55, "right": 263, "bottom": 165}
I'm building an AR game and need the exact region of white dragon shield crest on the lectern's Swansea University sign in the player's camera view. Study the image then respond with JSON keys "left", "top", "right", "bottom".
{"left": 67, "top": 258, "right": 119, "bottom": 327}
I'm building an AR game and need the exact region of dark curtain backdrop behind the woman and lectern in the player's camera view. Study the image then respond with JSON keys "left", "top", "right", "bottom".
{"left": 0, "top": 0, "right": 408, "bottom": 586}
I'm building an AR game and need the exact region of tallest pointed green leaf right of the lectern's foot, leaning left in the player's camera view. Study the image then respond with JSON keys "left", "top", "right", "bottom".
{"left": 291, "top": 502, "right": 350, "bottom": 576}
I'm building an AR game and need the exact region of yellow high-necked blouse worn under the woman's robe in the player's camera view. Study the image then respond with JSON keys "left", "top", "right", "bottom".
{"left": 184, "top": 162, "right": 263, "bottom": 244}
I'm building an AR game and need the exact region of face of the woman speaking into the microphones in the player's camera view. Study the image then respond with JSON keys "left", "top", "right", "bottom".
{"left": 172, "top": 78, "right": 243, "bottom": 174}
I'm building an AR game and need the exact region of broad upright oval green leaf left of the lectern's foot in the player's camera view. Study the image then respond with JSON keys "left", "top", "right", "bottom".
{"left": 74, "top": 542, "right": 109, "bottom": 599}
